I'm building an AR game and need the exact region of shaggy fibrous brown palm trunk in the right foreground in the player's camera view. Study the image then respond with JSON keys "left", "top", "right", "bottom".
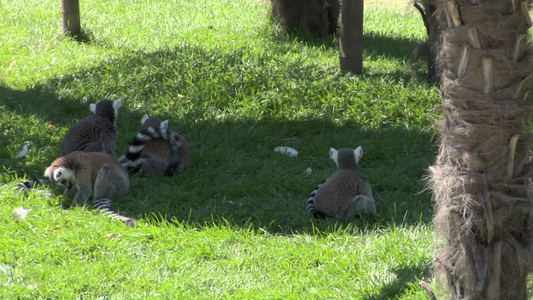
{"left": 429, "top": 0, "right": 533, "bottom": 299}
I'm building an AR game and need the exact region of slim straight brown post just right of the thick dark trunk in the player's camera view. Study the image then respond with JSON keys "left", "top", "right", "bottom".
{"left": 339, "top": 0, "right": 364, "bottom": 73}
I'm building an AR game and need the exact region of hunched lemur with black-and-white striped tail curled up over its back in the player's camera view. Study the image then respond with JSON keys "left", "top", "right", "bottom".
{"left": 120, "top": 115, "right": 192, "bottom": 176}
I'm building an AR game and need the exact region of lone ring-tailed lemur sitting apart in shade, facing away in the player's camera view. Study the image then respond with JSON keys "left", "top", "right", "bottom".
{"left": 306, "top": 147, "right": 376, "bottom": 220}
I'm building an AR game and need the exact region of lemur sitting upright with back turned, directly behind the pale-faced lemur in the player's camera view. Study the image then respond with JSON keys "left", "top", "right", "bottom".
{"left": 60, "top": 99, "right": 122, "bottom": 156}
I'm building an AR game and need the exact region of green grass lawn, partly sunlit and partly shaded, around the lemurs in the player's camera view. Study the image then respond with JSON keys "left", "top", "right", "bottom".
{"left": 0, "top": 0, "right": 439, "bottom": 299}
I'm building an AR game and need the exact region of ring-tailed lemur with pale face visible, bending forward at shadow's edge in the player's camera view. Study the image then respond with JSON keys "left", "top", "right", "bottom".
{"left": 44, "top": 151, "right": 137, "bottom": 227}
